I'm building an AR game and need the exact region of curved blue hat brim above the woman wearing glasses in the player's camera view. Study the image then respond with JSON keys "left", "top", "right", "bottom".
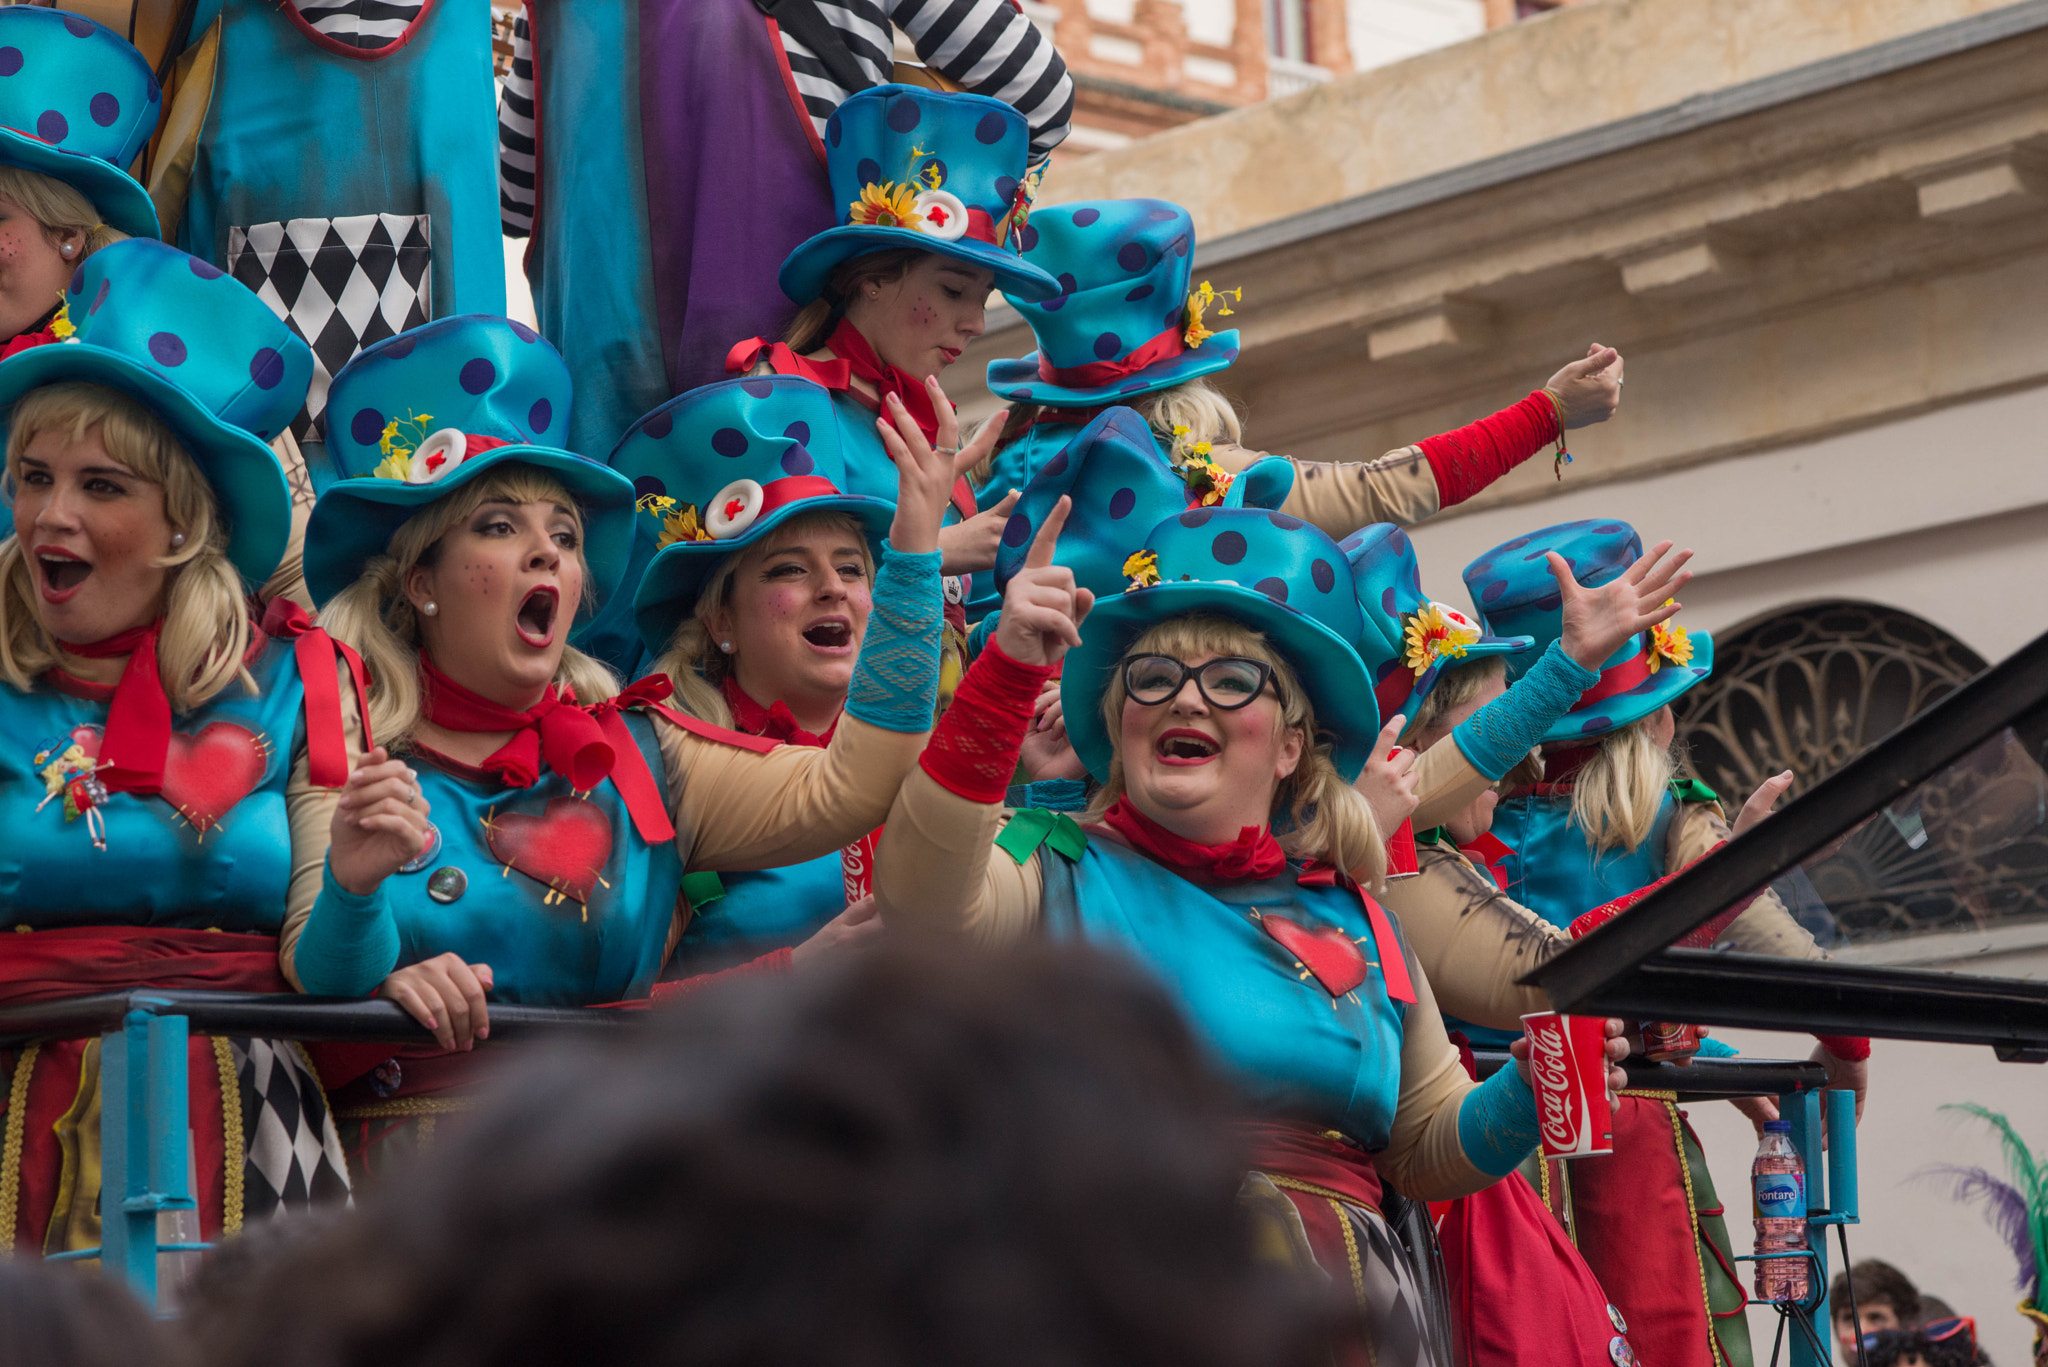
{"left": 1059, "top": 580, "right": 1380, "bottom": 783}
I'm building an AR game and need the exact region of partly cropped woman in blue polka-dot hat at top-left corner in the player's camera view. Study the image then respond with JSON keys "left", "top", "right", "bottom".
{"left": 0, "top": 4, "right": 164, "bottom": 357}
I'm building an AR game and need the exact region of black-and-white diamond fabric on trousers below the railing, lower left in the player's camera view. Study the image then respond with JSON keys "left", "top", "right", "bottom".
{"left": 227, "top": 1039, "right": 348, "bottom": 1219}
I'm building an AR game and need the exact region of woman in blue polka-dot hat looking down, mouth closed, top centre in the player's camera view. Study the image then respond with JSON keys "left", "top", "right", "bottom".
{"left": 727, "top": 86, "right": 1059, "bottom": 590}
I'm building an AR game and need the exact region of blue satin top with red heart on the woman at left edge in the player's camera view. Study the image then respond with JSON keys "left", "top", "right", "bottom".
{"left": 0, "top": 641, "right": 311, "bottom": 935}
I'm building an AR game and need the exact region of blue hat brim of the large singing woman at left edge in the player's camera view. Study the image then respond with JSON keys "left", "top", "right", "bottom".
{"left": 0, "top": 340, "right": 291, "bottom": 588}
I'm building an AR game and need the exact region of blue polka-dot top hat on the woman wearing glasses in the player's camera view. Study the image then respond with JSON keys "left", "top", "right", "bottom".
{"left": 1059, "top": 508, "right": 1380, "bottom": 781}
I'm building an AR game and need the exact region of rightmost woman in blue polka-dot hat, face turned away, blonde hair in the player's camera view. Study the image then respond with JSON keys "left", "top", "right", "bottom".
{"left": 1464, "top": 519, "right": 1870, "bottom": 1363}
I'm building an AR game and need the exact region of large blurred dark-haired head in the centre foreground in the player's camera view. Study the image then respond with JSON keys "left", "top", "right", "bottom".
{"left": 193, "top": 945, "right": 1327, "bottom": 1367}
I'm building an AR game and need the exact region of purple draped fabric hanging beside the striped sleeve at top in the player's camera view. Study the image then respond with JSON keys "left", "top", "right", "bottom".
{"left": 639, "top": 0, "right": 838, "bottom": 393}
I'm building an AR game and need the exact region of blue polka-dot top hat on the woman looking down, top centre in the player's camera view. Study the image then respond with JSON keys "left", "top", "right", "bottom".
{"left": 780, "top": 86, "right": 1059, "bottom": 303}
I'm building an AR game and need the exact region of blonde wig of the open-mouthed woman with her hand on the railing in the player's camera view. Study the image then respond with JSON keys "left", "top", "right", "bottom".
{"left": 319, "top": 465, "right": 618, "bottom": 748}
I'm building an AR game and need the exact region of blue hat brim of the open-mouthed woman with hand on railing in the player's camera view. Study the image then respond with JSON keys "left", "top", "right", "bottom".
{"left": 303, "top": 448, "right": 633, "bottom": 615}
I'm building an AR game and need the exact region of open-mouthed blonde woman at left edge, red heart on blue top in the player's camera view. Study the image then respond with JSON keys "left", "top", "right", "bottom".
{"left": 0, "top": 238, "right": 362, "bottom": 1252}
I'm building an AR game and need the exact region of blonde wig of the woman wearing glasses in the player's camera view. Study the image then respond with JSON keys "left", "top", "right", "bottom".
{"left": 1083, "top": 613, "right": 1386, "bottom": 885}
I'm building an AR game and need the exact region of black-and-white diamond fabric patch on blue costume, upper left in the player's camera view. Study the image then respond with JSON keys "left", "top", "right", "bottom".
{"left": 227, "top": 213, "right": 434, "bottom": 441}
